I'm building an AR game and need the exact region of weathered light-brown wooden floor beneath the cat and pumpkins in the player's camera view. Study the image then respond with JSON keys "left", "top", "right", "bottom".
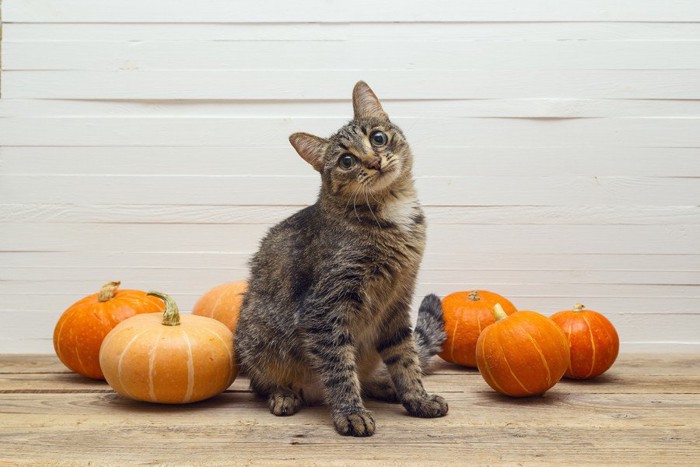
{"left": 0, "top": 355, "right": 700, "bottom": 465}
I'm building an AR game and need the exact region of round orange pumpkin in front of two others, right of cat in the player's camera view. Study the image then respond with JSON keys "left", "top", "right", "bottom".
{"left": 476, "top": 305, "right": 569, "bottom": 397}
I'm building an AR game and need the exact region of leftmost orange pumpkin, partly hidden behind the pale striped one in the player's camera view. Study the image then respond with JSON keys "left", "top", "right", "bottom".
{"left": 53, "top": 282, "right": 164, "bottom": 379}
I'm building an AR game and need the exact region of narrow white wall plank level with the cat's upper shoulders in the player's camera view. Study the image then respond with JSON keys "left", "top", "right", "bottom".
{"left": 0, "top": 203, "right": 700, "bottom": 227}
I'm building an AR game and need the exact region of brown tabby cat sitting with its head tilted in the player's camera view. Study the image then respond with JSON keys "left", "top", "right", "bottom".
{"left": 234, "top": 81, "right": 448, "bottom": 436}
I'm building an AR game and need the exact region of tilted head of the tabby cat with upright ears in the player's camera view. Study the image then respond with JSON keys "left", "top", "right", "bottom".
{"left": 289, "top": 81, "right": 413, "bottom": 196}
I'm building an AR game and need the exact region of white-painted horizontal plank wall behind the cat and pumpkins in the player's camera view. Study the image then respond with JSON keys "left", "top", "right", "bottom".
{"left": 0, "top": 0, "right": 700, "bottom": 353}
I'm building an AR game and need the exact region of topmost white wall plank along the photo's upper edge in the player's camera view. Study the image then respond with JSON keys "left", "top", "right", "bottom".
{"left": 3, "top": 0, "right": 700, "bottom": 23}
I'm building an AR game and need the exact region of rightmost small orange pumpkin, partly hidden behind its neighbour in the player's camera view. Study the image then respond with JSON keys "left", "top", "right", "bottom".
{"left": 552, "top": 303, "right": 620, "bottom": 379}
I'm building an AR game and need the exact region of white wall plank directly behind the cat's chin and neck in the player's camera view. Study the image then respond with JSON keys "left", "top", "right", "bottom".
{"left": 0, "top": 176, "right": 700, "bottom": 209}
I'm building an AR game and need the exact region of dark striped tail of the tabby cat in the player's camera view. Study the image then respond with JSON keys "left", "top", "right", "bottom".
{"left": 414, "top": 294, "right": 447, "bottom": 372}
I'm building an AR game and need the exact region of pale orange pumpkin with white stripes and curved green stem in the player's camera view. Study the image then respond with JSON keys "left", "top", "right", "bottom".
{"left": 100, "top": 292, "right": 238, "bottom": 404}
